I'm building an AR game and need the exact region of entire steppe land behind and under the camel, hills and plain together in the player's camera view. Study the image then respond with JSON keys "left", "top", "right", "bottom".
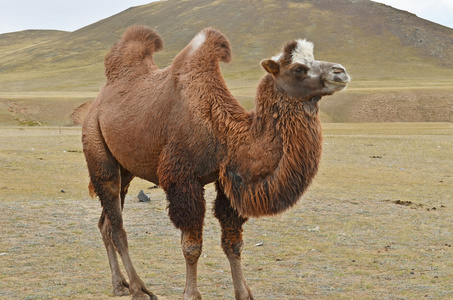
{"left": 0, "top": 0, "right": 453, "bottom": 300}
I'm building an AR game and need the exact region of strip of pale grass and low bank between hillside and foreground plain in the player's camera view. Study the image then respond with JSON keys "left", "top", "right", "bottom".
{"left": 0, "top": 79, "right": 453, "bottom": 126}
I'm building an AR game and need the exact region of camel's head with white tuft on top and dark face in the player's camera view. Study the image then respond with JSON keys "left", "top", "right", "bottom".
{"left": 261, "top": 40, "right": 350, "bottom": 102}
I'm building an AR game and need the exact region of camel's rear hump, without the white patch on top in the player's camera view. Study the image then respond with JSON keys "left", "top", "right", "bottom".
{"left": 104, "top": 25, "right": 163, "bottom": 81}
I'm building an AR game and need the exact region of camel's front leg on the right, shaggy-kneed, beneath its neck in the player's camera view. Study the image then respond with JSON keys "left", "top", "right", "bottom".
{"left": 214, "top": 183, "right": 254, "bottom": 300}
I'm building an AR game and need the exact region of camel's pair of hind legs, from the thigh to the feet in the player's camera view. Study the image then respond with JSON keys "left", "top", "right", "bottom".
{"left": 84, "top": 131, "right": 157, "bottom": 300}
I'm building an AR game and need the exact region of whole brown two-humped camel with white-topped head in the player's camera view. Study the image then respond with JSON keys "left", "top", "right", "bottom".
{"left": 82, "top": 25, "right": 350, "bottom": 300}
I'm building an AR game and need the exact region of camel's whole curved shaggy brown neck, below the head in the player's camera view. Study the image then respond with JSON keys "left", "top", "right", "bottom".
{"left": 220, "top": 78, "right": 322, "bottom": 217}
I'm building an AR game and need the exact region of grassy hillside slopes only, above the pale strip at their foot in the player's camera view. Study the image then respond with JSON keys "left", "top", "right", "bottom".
{"left": 0, "top": 0, "right": 453, "bottom": 123}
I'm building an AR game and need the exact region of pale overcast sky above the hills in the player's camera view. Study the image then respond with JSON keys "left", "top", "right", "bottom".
{"left": 0, "top": 0, "right": 453, "bottom": 34}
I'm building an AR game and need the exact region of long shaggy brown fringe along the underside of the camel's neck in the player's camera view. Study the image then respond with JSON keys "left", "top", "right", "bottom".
{"left": 220, "top": 76, "right": 322, "bottom": 217}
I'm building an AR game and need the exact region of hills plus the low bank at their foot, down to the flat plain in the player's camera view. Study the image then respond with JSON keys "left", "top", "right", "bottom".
{"left": 0, "top": 0, "right": 453, "bottom": 124}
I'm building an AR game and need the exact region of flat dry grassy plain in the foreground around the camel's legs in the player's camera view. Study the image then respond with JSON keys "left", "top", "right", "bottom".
{"left": 0, "top": 123, "right": 453, "bottom": 300}
